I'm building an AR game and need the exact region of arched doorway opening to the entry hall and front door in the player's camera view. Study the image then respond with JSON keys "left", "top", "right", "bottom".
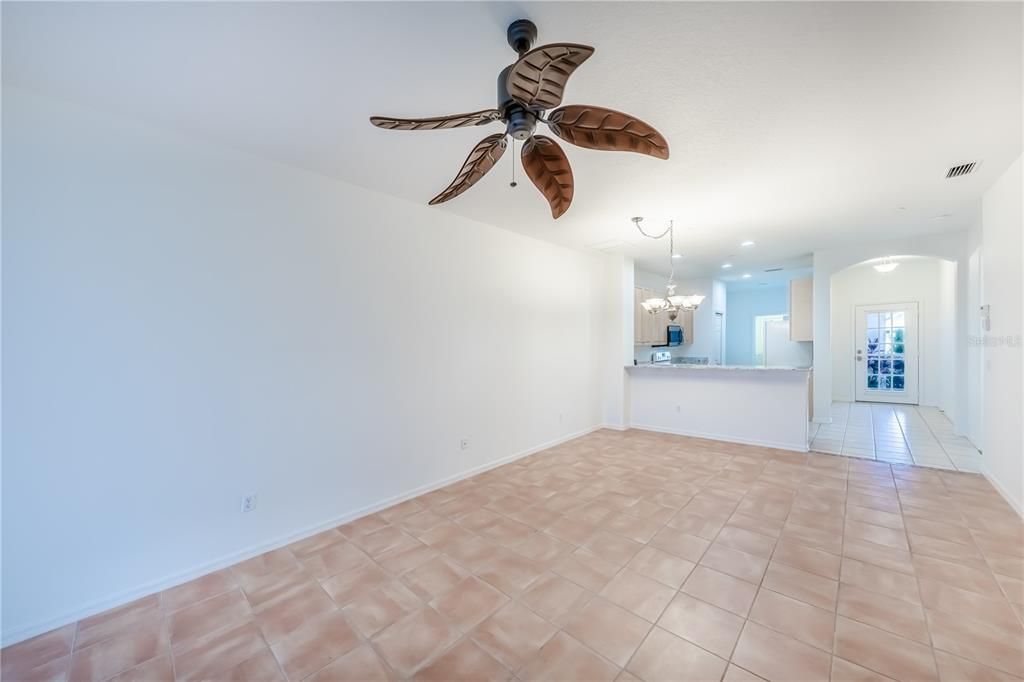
{"left": 812, "top": 255, "right": 981, "bottom": 471}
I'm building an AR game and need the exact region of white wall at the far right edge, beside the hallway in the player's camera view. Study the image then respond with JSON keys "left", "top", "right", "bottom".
{"left": 974, "top": 158, "right": 1024, "bottom": 512}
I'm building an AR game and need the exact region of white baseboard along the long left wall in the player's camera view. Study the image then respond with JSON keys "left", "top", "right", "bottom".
{"left": 0, "top": 425, "right": 598, "bottom": 646}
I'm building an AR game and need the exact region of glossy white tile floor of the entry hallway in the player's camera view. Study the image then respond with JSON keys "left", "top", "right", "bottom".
{"left": 811, "top": 402, "right": 981, "bottom": 472}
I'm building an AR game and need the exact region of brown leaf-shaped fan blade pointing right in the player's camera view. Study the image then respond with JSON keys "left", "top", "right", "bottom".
{"left": 548, "top": 104, "right": 669, "bottom": 159}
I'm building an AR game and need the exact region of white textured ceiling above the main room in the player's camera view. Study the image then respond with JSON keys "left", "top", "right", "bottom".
{"left": 2, "top": 2, "right": 1022, "bottom": 276}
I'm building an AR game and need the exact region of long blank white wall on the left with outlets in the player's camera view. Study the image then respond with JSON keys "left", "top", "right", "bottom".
{"left": 2, "top": 88, "right": 621, "bottom": 642}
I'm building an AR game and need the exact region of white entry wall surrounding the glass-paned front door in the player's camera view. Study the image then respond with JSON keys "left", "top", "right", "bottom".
{"left": 830, "top": 258, "right": 956, "bottom": 410}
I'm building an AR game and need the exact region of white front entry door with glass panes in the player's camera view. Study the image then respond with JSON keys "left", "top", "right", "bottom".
{"left": 853, "top": 303, "right": 920, "bottom": 403}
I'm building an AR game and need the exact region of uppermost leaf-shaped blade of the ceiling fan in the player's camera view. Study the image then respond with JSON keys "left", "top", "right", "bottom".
{"left": 506, "top": 43, "right": 594, "bottom": 109}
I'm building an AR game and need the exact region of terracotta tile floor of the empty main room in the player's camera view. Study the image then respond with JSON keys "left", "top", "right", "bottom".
{"left": 2, "top": 431, "right": 1024, "bottom": 682}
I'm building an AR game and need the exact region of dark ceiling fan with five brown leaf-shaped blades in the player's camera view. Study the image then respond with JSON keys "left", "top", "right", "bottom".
{"left": 370, "top": 19, "right": 669, "bottom": 218}
